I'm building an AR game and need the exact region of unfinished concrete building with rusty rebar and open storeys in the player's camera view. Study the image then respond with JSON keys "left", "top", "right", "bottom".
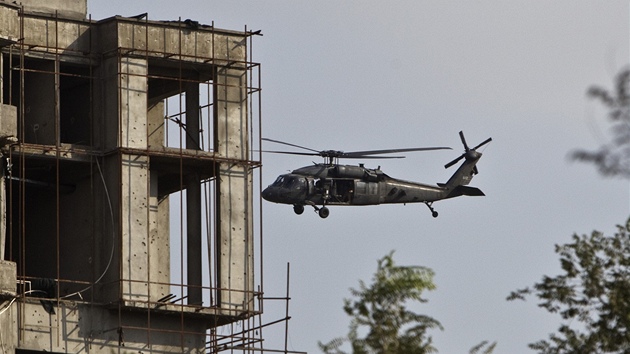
{"left": 0, "top": 0, "right": 276, "bottom": 353}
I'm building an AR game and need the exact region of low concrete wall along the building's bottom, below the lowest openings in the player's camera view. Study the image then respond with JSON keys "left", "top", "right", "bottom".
{"left": 17, "top": 300, "right": 206, "bottom": 353}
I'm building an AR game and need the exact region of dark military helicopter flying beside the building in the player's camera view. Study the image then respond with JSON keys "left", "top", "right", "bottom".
{"left": 262, "top": 131, "right": 492, "bottom": 218}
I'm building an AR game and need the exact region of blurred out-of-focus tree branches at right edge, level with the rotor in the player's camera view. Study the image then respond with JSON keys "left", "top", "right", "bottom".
{"left": 571, "top": 68, "right": 630, "bottom": 178}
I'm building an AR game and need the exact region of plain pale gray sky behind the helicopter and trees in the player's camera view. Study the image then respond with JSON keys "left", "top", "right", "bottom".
{"left": 88, "top": 0, "right": 630, "bottom": 353}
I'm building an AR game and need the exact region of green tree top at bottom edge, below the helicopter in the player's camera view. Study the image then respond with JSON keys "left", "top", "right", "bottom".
{"left": 319, "top": 251, "right": 442, "bottom": 354}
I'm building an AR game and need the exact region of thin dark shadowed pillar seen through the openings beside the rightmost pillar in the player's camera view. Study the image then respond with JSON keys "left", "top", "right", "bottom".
{"left": 186, "top": 83, "right": 203, "bottom": 305}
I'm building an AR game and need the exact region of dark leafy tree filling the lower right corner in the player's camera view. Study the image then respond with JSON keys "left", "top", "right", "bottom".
{"left": 508, "top": 219, "right": 630, "bottom": 354}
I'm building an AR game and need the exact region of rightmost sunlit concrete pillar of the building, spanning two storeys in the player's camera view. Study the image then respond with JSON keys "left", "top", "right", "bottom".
{"left": 214, "top": 68, "right": 254, "bottom": 314}
